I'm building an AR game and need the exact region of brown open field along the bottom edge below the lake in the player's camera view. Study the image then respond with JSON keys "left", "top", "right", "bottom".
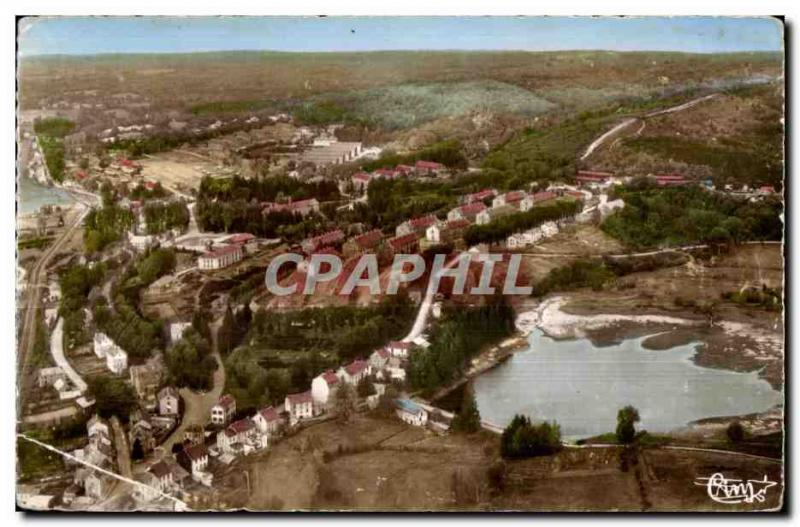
{"left": 198, "top": 415, "right": 782, "bottom": 511}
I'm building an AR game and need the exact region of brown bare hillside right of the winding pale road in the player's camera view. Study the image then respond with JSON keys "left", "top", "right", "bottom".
{"left": 587, "top": 85, "right": 783, "bottom": 188}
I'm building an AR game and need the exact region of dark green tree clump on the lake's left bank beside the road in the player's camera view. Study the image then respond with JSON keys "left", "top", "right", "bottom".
{"left": 408, "top": 297, "right": 514, "bottom": 390}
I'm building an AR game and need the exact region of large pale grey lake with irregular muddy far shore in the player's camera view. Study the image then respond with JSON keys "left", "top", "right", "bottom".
{"left": 474, "top": 328, "right": 783, "bottom": 439}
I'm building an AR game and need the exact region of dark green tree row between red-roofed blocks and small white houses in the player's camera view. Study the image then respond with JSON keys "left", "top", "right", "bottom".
{"left": 464, "top": 199, "right": 581, "bottom": 245}
